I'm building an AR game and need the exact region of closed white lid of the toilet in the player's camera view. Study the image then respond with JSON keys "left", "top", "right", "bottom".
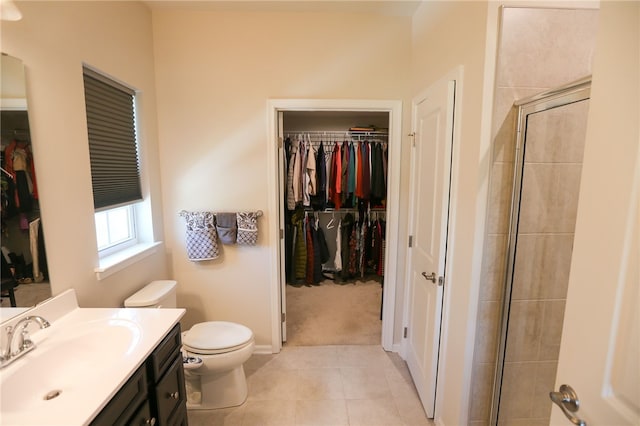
{"left": 182, "top": 321, "right": 253, "bottom": 353}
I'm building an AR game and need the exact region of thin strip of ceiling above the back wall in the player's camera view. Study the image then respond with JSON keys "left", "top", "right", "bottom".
{"left": 144, "top": 0, "right": 421, "bottom": 16}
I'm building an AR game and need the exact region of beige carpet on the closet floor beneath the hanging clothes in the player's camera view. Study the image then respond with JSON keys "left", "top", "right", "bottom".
{"left": 285, "top": 280, "right": 382, "bottom": 346}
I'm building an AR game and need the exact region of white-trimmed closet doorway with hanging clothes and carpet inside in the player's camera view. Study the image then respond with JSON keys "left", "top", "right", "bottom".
{"left": 264, "top": 100, "right": 400, "bottom": 350}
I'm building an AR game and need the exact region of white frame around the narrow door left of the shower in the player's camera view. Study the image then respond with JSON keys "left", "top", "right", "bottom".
{"left": 400, "top": 66, "right": 468, "bottom": 423}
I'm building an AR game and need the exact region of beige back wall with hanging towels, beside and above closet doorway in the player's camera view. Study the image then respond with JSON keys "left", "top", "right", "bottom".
{"left": 153, "top": 7, "right": 411, "bottom": 346}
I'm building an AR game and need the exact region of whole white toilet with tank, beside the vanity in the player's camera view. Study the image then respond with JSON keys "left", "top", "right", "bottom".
{"left": 124, "top": 280, "right": 255, "bottom": 410}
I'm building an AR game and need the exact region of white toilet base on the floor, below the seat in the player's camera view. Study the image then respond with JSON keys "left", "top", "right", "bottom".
{"left": 185, "top": 365, "right": 248, "bottom": 410}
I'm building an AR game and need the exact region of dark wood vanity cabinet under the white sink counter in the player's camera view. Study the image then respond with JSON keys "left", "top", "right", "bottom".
{"left": 91, "top": 324, "right": 188, "bottom": 426}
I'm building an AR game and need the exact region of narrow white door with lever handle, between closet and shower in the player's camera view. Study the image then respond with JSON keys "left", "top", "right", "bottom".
{"left": 405, "top": 80, "right": 455, "bottom": 418}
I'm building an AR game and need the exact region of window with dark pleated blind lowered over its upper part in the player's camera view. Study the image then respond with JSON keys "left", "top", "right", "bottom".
{"left": 83, "top": 67, "right": 142, "bottom": 257}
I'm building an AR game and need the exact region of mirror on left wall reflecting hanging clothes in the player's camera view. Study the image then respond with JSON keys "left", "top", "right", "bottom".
{"left": 0, "top": 53, "right": 51, "bottom": 312}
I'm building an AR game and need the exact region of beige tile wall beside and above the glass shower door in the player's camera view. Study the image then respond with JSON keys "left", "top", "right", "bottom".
{"left": 470, "top": 5, "right": 598, "bottom": 425}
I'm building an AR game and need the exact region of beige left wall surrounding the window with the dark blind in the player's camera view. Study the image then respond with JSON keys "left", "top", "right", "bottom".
{"left": 1, "top": 2, "right": 167, "bottom": 307}
